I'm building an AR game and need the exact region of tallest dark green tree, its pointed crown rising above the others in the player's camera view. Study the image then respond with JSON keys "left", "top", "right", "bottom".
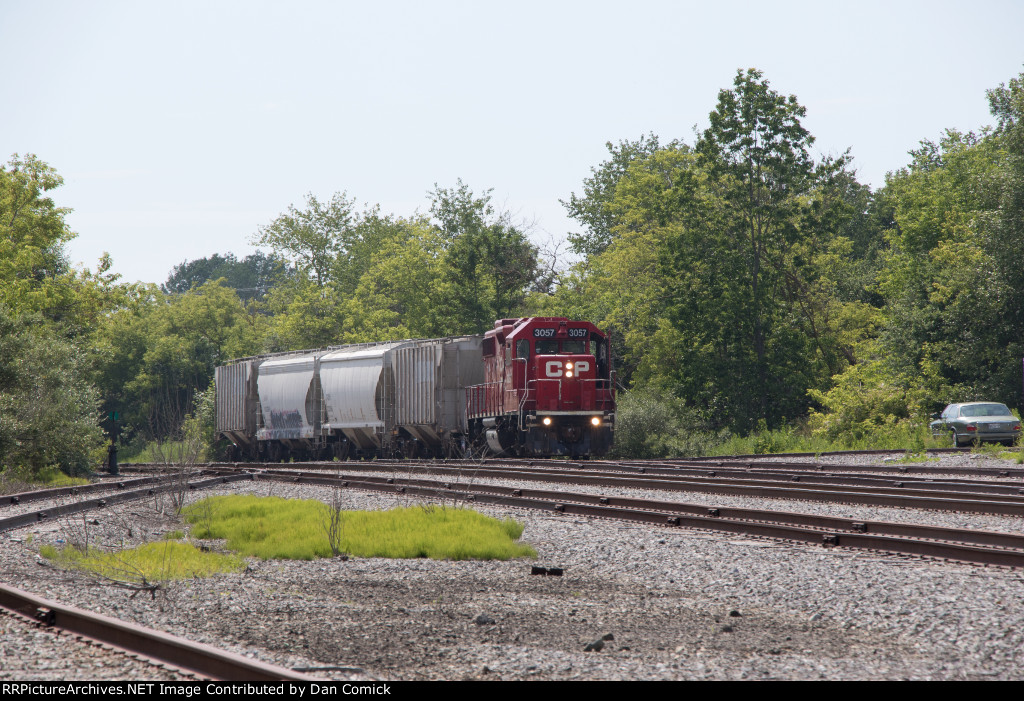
{"left": 666, "top": 69, "right": 846, "bottom": 429}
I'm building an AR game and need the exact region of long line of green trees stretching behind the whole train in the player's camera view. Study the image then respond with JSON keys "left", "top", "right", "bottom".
{"left": 0, "top": 69, "right": 1024, "bottom": 471}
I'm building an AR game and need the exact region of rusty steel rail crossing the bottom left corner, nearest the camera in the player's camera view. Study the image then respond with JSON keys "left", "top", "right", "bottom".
{"left": 0, "top": 584, "right": 314, "bottom": 682}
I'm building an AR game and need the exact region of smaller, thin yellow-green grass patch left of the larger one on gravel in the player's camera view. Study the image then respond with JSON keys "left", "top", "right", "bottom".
{"left": 39, "top": 540, "right": 246, "bottom": 583}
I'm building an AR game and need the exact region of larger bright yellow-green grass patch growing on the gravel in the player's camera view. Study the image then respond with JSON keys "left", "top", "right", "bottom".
{"left": 182, "top": 495, "right": 537, "bottom": 560}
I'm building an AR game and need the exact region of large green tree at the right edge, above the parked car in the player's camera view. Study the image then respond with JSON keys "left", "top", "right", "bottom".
{"left": 880, "top": 71, "right": 1024, "bottom": 406}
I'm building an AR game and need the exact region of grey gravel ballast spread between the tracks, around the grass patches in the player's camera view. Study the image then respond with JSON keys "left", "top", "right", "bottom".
{"left": 6, "top": 455, "right": 1024, "bottom": 680}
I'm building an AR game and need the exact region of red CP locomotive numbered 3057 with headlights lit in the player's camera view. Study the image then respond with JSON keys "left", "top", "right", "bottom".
{"left": 466, "top": 316, "right": 615, "bottom": 456}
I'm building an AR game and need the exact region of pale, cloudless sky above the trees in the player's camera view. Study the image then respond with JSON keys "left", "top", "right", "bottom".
{"left": 0, "top": 0, "right": 1024, "bottom": 282}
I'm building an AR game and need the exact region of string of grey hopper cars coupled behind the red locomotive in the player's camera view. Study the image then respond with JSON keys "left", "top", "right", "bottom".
{"left": 216, "top": 336, "right": 483, "bottom": 461}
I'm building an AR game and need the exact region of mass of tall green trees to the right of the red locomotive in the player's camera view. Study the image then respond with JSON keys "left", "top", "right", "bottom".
{"left": 552, "top": 70, "right": 1024, "bottom": 454}
